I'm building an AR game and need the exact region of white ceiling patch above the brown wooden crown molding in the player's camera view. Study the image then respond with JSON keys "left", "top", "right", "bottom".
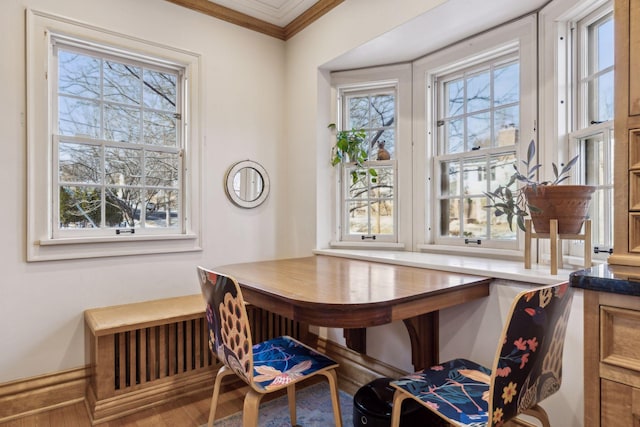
{"left": 209, "top": 0, "right": 318, "bottom": 27}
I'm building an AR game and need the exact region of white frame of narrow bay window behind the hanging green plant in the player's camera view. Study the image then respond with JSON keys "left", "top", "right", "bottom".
{"left": 330, "top": 64, "right": 412, "bottom": 249}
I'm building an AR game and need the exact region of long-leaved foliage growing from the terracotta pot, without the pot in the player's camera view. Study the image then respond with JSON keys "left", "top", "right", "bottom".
{"left": 484, "top": 140, "right": 579, "bottom": 231}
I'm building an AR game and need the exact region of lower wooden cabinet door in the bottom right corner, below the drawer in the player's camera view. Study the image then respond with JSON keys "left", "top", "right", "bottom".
{"left": 600, "top": 379, "right": 640, "bottom": 427}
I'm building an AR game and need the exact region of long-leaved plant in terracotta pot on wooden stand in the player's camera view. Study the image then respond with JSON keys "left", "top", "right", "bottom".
{"left": 485, "top": 140, "right": 595, "bottom": 234}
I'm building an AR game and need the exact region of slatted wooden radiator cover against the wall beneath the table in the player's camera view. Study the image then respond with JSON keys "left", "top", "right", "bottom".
{"left": 85, "top": 295, "right": 308, "bottom": 425}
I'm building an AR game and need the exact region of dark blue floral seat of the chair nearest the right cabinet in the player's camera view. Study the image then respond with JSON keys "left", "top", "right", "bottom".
{"left": 393, "top": 359, "right": 491, "bottom": 427}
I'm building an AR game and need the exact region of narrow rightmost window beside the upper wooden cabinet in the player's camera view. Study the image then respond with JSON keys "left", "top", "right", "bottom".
{"left": 569, "top": 4, "right": 614, "bottom": 257}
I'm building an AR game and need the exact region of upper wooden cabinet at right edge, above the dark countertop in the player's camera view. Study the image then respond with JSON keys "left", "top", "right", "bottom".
{"left": 608, "top": 0, "right": 640, "bottom": 266}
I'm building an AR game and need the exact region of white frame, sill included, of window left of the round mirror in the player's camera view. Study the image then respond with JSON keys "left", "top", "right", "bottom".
{"left": 27, "top": 10, "right": 201, "bottom": 261}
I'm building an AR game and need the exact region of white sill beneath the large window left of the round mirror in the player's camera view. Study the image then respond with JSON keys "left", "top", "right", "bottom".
{"left": 27, "top": 234, "right": 202, "bottom": 261}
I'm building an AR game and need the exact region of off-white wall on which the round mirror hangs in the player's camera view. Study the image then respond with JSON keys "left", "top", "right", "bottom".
{"left": 0, "top": 0, "right": 287, "bottom": 383}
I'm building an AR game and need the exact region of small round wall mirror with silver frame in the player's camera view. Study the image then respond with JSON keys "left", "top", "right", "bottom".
{"left": 225, "top": 160, "right": 269, "bottom": 209}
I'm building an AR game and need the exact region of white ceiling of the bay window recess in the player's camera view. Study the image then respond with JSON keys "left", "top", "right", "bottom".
{"left": 324, "top": 0, "right": 549, "bottom": 70}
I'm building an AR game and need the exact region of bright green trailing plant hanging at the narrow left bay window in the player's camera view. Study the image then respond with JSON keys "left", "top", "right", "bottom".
{"left": 327, "top": 123, "right": 378, "bottom": 184}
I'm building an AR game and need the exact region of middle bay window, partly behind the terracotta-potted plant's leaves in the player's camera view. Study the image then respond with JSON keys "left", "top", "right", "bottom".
{"left": 412, "top": 15, "right": 538, "bottom": 254}
